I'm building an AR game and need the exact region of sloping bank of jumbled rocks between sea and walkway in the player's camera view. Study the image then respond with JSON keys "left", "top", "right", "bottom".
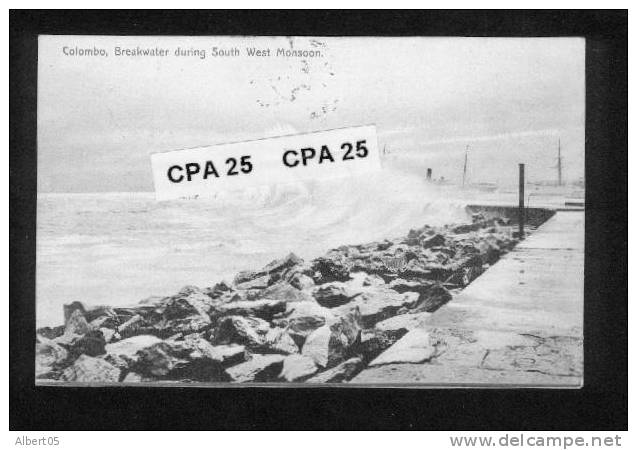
{"left": 36, "top": 216, "right": 517, "bottom": 383}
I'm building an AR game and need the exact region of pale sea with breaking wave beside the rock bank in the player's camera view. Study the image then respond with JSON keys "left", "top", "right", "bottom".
{"left": 36, "top": 168, "right": 467, "bottom": 326}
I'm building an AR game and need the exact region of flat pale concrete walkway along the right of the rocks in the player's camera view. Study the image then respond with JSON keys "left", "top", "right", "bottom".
{"left": 351, "top": 211, "right": 584, "bottom": 387}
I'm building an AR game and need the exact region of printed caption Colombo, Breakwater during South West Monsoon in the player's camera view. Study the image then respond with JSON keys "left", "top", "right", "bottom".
{"left": 60, "top": 43, "right": 325, "bottom": 59}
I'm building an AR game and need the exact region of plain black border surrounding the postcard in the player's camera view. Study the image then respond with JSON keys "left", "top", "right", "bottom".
{"left": 9, "top": 10, "right": 628, "bottom": 430}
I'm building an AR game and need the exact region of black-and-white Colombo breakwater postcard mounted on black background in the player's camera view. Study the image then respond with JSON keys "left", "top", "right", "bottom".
{"left": 34, "top": 35, "right": 586, "bottom": 388}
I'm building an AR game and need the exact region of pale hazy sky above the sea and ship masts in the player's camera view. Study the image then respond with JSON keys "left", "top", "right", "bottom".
{"left": 38, "top": 36, "right": 585, "bottom": 192}
